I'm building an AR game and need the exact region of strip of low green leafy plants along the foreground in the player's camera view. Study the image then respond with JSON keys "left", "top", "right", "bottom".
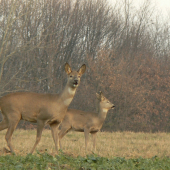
{"left": 0, "top": 153, "right": 170, "bottom": 170}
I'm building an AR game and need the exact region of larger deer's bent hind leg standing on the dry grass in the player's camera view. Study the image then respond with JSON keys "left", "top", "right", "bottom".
{"left": 4, "top": 119, "right": 20, "bottom": 153}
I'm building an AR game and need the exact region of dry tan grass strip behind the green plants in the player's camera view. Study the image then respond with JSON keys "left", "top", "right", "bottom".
{"left": 0, "top": 130, "right": 170, "bottom": 158}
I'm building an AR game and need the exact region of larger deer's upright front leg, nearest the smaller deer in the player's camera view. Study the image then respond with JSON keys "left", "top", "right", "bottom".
{"left": 50, "top": 122, "right": 60, "bottom": 152}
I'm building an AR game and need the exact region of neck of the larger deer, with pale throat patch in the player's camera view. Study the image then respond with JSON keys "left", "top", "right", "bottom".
{"left": 60, "top": 85, "right": 76, "bottom": 107}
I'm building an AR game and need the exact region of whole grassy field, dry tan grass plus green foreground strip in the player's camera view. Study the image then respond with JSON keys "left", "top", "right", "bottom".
{"left": 0, "top": 130, "right": 170, "bottom": 169}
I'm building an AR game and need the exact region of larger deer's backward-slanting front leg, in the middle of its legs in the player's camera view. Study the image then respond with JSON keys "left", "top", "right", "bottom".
{"left": 30, "top": 121, "right": 45, "bottom": 154}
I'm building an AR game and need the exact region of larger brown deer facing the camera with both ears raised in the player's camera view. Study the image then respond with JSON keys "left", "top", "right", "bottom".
{"left": 0, "top": 63, "right": 86, "bottom": 154}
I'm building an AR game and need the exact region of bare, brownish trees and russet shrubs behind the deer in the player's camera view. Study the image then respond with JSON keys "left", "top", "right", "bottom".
{"left": 0, "top": 0, "right": 170, "bottom": 132}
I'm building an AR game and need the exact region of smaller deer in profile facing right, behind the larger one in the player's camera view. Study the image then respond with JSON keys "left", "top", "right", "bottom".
{"left": 59, "top": 92, "right": 115, "bottom": 151}
